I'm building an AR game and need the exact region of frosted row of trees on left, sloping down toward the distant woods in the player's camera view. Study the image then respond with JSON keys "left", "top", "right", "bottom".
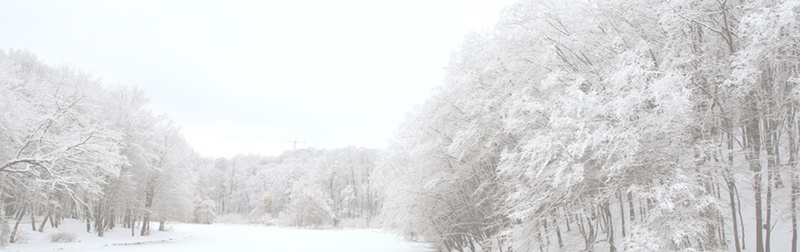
{"left": 0, "top": 50, "right": 199, "bottom": 243}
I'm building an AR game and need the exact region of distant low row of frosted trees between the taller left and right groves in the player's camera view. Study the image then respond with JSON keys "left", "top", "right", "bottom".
{"left": 197, "top": 147, "right": 381, "bottom": 227}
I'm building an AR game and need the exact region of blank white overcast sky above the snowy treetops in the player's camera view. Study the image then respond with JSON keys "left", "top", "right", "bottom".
{"left": 0, "top": 0, "right": 513, "bottom": 157}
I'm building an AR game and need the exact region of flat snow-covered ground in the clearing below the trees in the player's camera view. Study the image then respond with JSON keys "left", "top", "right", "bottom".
{"left": 0, "top": 220, "right": 432, "bottom": 252}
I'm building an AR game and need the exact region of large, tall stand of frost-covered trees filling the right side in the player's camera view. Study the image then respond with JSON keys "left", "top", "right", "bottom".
{"left": 376, "top": 0, "right": 800, "bottom": 251}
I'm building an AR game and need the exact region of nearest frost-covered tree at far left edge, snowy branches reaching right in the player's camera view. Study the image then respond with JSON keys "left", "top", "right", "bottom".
{"left": 0, "top": 50, "right": 124, "bottom": 242}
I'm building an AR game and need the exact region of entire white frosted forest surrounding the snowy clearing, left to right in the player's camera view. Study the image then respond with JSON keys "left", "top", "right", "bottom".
{"left": 0, "top": 0, "right": 800, "bottom": 252}
